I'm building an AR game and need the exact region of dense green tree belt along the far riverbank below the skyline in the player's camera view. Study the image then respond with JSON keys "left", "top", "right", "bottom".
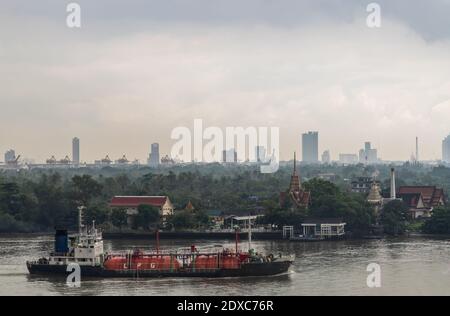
{"left": 0, "top": 164, "right": 450, "bottom": 234}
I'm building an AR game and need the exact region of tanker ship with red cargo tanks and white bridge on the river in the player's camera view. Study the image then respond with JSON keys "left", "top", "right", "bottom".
{"left": 26, "top": 208, "right": 294, "bottom": 278}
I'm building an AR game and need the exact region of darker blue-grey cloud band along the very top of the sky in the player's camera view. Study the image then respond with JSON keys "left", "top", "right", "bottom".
{"left": 0, "top": 0, "right": 450, "bottom": 40}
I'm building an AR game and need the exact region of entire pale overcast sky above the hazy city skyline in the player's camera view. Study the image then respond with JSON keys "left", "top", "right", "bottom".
{"left": 0, "top": 0, "right": 450, "bottom": 161}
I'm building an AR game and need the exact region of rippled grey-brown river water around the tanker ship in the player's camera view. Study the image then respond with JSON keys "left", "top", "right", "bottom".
{"left": 0, "top": 235, "right": 450, "bottom": 296}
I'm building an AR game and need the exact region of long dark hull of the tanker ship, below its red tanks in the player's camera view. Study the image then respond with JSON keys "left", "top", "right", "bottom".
{"left": 27, "top": 261, "right": 292, "bottom": 278}
